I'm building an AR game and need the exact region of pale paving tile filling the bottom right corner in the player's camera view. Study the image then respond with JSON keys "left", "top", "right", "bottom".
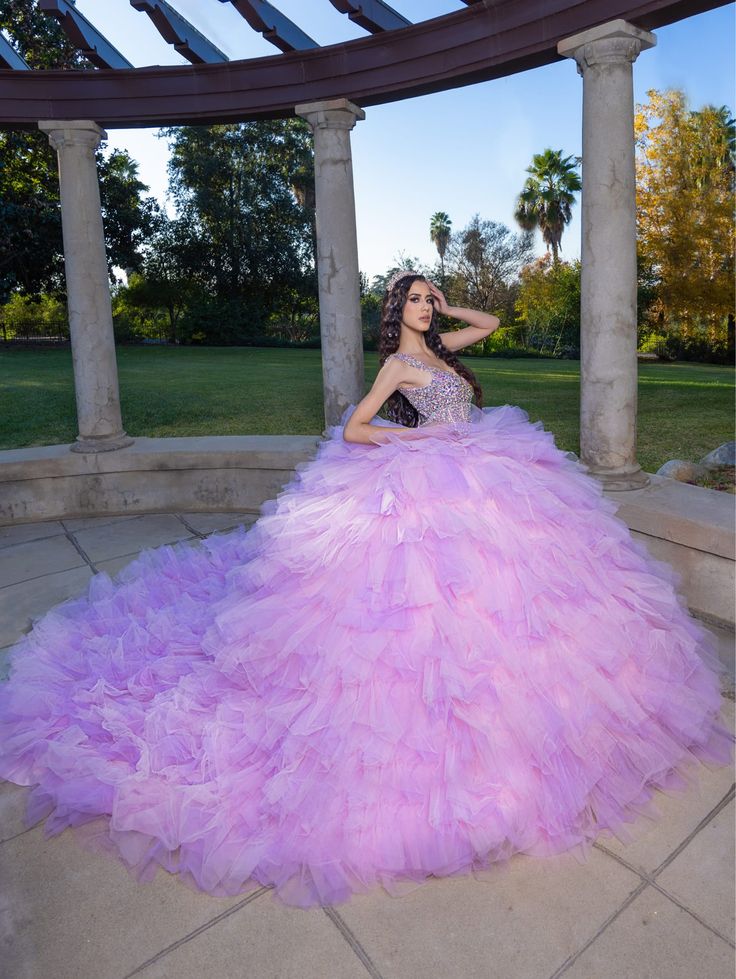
{"left": 564, "top": 887, "right": 733, "bottom": 979}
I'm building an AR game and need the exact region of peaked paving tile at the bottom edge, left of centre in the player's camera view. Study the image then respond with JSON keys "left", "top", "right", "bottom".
{"left": 140, "top": 893, "right": 369, "bottom": 979}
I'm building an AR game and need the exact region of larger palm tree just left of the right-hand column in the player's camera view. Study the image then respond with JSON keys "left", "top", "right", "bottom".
{"left": 514, "top": 149, "right": 582, "bottom": 262}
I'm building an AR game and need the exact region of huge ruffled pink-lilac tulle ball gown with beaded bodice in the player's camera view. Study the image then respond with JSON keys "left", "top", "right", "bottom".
{"left": 0, "top": 354, "right": 731, "bottom": 906}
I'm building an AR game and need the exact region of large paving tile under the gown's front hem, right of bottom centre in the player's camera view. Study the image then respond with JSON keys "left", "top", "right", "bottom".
{"left": 337, "top": 850, "right": 641, "bottom": 979}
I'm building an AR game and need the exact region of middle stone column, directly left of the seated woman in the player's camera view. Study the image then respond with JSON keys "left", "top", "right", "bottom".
{"left": 296, "top": 99, "right": 365, "bottom": 426}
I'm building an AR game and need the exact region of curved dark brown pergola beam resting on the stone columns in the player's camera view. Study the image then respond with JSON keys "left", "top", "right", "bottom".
{"left": 0, "top": 0, "right": 728, "bottom": 128}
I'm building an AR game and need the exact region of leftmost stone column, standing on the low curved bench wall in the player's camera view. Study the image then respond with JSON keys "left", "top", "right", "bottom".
{"left": 38, "top": 119, "right": 133, "bottom": 452}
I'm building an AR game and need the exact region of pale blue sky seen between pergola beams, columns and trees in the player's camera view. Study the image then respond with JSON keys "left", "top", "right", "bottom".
{"left": 77, "top": 0, "right": 736, "bottom": 276}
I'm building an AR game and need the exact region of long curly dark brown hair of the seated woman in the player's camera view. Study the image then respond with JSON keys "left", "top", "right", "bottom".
{"left": 378, "top": 274, "right": 483, "bottom": 428}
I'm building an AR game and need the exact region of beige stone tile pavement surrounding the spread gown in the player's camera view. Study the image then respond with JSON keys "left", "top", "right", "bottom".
{"left": 0, "top": 514, "right": 734, "bottom": 979}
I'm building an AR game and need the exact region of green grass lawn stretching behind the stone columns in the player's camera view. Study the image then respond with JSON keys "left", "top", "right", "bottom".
{"left": 0, "top": 347, "right": 734, "bottom": 472}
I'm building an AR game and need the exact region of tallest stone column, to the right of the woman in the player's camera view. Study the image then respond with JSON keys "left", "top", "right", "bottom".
{"left": 557, "top": 20, "right": 656, "bottom": 490}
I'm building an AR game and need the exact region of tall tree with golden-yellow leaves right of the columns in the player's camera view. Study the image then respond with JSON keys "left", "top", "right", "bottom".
{"left": 635, "top": 90, "right": 736, "bottom": 360}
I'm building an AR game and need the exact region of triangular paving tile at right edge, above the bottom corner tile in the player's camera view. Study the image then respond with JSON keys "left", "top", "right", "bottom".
{"left": 657, "top": 802, "right": 736, "bottom": 941}
